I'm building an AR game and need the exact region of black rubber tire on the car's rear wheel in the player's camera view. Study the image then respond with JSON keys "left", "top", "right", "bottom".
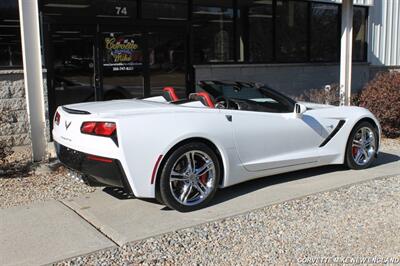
{"left": 159, "top": 142, "right": 221, "bottom": 212}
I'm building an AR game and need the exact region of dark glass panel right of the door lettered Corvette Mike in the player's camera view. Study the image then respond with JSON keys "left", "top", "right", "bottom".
{"left": 147, "top": 31, "right": 187, "bottom": 97}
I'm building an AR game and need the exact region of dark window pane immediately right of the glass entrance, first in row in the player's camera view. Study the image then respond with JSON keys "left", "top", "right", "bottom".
{"left": 193, "top": 0, "right": 233, "bottom": 63}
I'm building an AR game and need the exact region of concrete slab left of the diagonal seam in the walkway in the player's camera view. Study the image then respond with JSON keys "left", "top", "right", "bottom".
{"left": 0, "top": 200, "right": 114, "bottom": 265}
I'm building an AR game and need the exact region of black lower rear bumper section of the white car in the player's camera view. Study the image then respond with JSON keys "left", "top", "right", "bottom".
{"left": 54, "top": 142, "right": 132, "bottom": 193}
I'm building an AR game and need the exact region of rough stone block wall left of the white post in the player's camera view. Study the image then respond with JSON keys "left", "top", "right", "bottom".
{"left": 0, "top": 70, "right": 31, "bottom": 147}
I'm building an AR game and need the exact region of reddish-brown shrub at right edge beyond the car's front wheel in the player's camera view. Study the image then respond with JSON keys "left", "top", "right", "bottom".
{"left": 359, "top": 71, "right": 400, "bottom": 138}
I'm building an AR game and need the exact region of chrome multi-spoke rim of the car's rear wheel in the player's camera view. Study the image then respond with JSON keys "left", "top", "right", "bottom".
{"left": 169, "top": 150, "right": 216, "bottom": 206}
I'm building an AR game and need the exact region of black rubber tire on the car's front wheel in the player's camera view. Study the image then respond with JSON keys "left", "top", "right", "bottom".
{"left": 345, "top": 121, "right": 379, "bottom": 170}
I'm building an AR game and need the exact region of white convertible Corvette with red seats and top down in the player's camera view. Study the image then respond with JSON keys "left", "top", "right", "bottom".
{"left": 53, "top": 81, "right": 381, "bottom": 211}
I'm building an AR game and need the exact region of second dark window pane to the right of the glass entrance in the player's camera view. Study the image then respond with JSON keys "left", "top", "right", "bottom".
{"left": 238, "top": 0, "right": 273, "bottom": 62}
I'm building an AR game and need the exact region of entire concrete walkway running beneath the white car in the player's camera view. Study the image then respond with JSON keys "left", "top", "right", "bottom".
{"left": 0, "top": 151, "right": 400, "bottom": 265}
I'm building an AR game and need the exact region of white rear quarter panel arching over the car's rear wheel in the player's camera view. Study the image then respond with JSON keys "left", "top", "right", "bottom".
{"left": 118, "top": 108, "right": 245, "bottom": 197}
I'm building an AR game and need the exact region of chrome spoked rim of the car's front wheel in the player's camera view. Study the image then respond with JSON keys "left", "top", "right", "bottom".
{"left": 351, "top": 127, "right": 376, "bottom": 166}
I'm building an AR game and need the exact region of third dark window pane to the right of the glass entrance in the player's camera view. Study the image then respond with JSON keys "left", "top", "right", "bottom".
{"left": 276, "top": 1, "right": 308, "bottom": 62}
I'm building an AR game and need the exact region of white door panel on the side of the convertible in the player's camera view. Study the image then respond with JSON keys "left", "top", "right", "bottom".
{"left": 230, "top": 111, "right": 323, "bottom": 171}
